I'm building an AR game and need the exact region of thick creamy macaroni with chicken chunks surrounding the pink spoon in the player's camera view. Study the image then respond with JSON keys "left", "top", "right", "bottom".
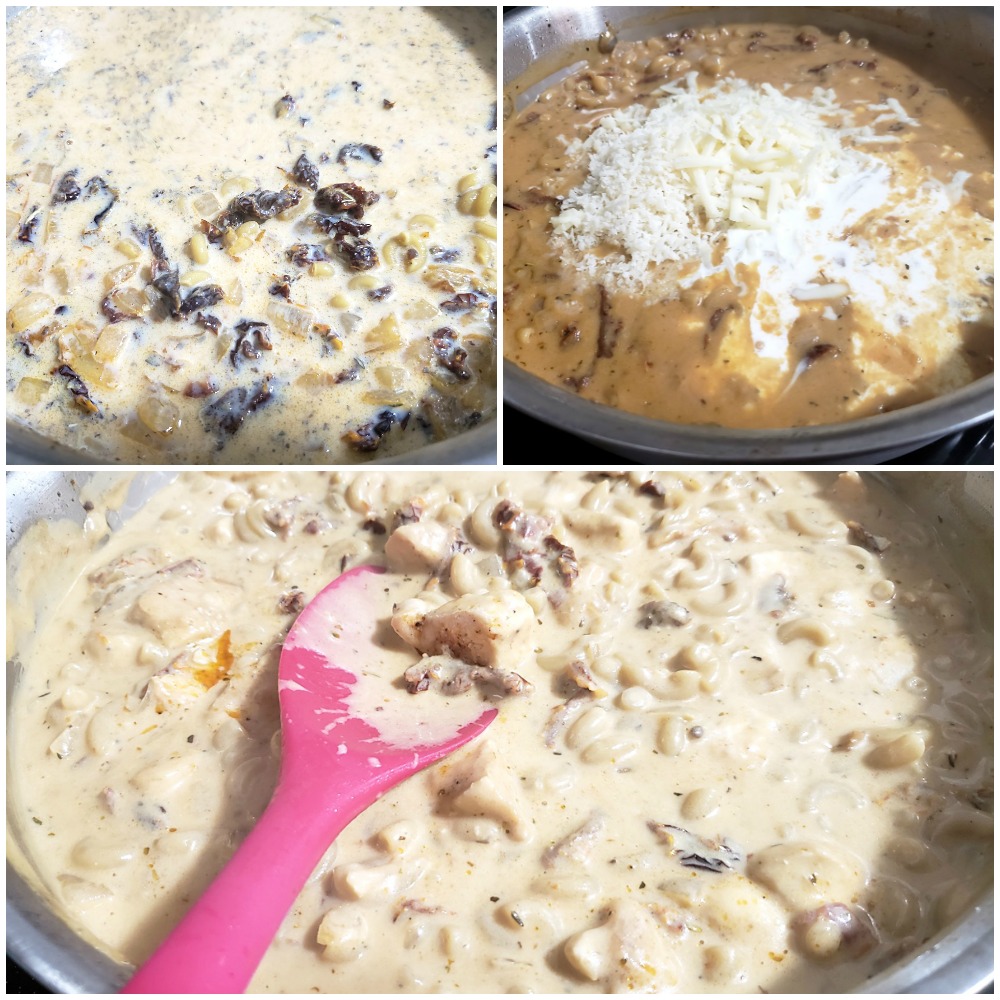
{"left": 8, "top": 472, "right": 993, "bottom": 993}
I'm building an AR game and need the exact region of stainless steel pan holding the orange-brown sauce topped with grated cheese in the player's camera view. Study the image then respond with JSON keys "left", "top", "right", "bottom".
{"left": 503, "top": 7, "right": 994, "bottom": 463}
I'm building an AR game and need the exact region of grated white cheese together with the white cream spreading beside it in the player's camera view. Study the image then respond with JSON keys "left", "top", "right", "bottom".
{"left": 552, "top": 73, "right": 992, "bottom": 365}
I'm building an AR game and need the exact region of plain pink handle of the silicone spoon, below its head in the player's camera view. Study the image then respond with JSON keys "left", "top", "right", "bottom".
{"left": 122, "top": 785, "right": 364, "bottom": 993}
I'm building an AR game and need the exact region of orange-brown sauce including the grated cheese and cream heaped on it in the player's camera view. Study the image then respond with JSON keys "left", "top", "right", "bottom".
{"left": 504, "top": 24, "right": 993, "bottom": 427}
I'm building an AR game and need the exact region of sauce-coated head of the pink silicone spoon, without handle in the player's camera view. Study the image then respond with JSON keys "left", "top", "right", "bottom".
{"left": 278, "top": 566, "right": 496, "bottom": 775}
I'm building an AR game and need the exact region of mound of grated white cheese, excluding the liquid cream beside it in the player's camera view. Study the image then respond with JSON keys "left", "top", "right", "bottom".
{"left": 553, "top": 73, "right": 898, "bottom": 285}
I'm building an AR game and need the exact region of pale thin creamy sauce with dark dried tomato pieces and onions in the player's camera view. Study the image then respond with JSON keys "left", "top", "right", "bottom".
{"left": 7, "top": 6, "right": 497, "bottom": 463}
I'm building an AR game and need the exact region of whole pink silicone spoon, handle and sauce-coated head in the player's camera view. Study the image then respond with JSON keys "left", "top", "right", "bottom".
{"left": 123, "top": 566, "right": 496, "bottom": 993}
